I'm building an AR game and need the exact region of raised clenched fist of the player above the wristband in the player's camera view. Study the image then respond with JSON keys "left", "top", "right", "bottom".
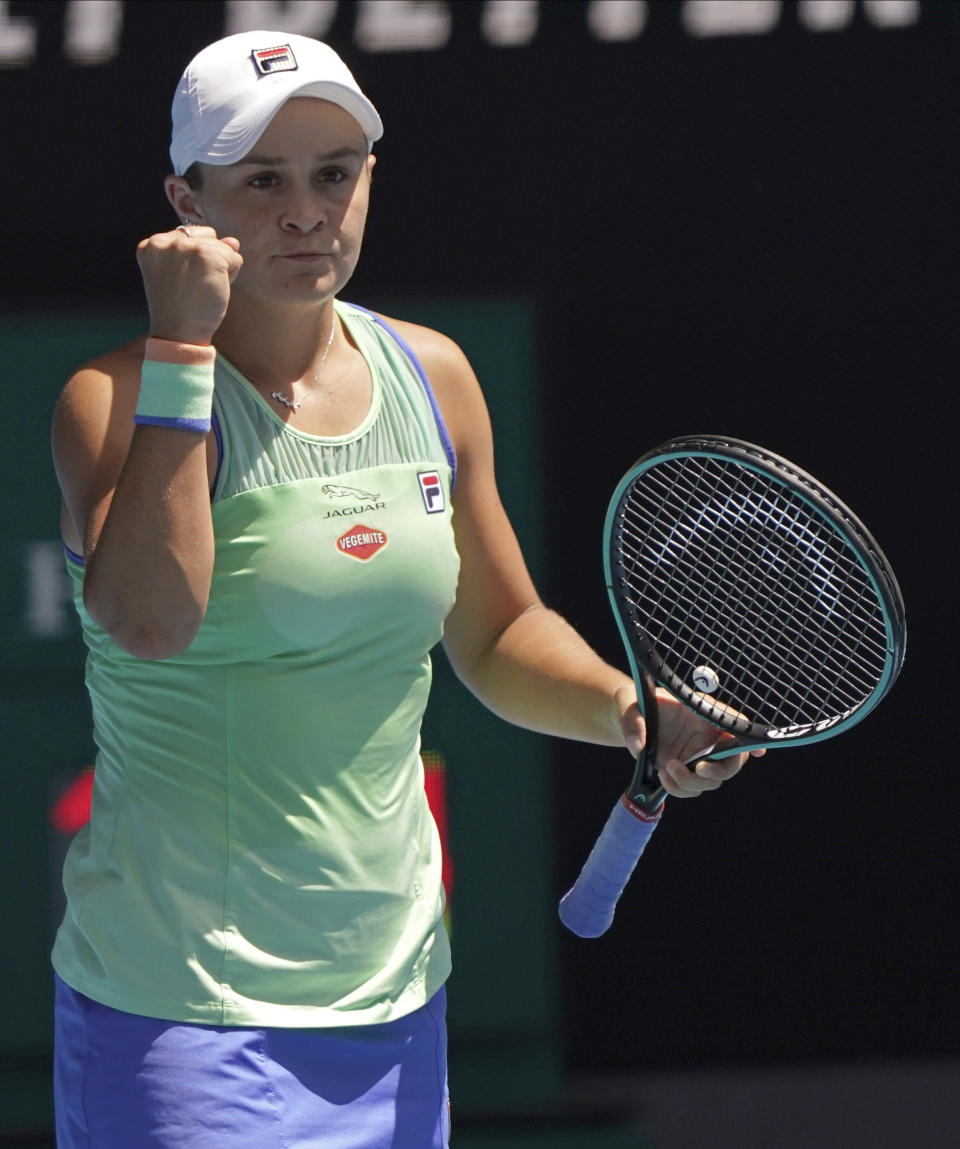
{"left": 137, "top": 224, "right": 243, "bottom": 345}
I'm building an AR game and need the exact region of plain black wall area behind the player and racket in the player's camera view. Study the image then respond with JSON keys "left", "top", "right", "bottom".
{"left": 0, "top": 0, "right": 960, "bottom": 1071}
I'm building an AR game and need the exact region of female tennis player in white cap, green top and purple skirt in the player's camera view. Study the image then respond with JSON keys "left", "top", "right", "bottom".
{"left": 53, "top": 32, "right": 743, "bottom": 1149}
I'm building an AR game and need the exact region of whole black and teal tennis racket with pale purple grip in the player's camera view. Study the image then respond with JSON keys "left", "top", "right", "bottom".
{"left": 559, "top": 435, "right": 906, "bottom": 938}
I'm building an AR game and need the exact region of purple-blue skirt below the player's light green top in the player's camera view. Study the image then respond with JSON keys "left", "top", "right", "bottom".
{"left": 54, "top": 978, "right": 450, "bottom": 1149}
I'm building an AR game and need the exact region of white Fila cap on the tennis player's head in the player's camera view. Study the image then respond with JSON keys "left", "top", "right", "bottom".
{"left": 170, "top": 32, "right": 384, "bottom": 176}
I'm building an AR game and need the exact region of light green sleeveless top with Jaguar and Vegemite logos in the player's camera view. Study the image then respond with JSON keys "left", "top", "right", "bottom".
{"left": 53, "top": 303, "right": 458, "bottom": 1027}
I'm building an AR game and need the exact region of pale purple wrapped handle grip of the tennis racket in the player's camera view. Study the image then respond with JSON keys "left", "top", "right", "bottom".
{"left": 559, "top": 794, "right": 663, "bottom": 938}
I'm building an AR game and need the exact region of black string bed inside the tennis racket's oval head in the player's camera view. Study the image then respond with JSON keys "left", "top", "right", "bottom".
{"left": 618, "top": 457, "right": 888, "bottom": 728}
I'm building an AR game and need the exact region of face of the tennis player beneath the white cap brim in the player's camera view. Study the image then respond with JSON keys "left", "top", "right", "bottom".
{"left": 177, "top": 97, "right": 374, "bottom": 303}
